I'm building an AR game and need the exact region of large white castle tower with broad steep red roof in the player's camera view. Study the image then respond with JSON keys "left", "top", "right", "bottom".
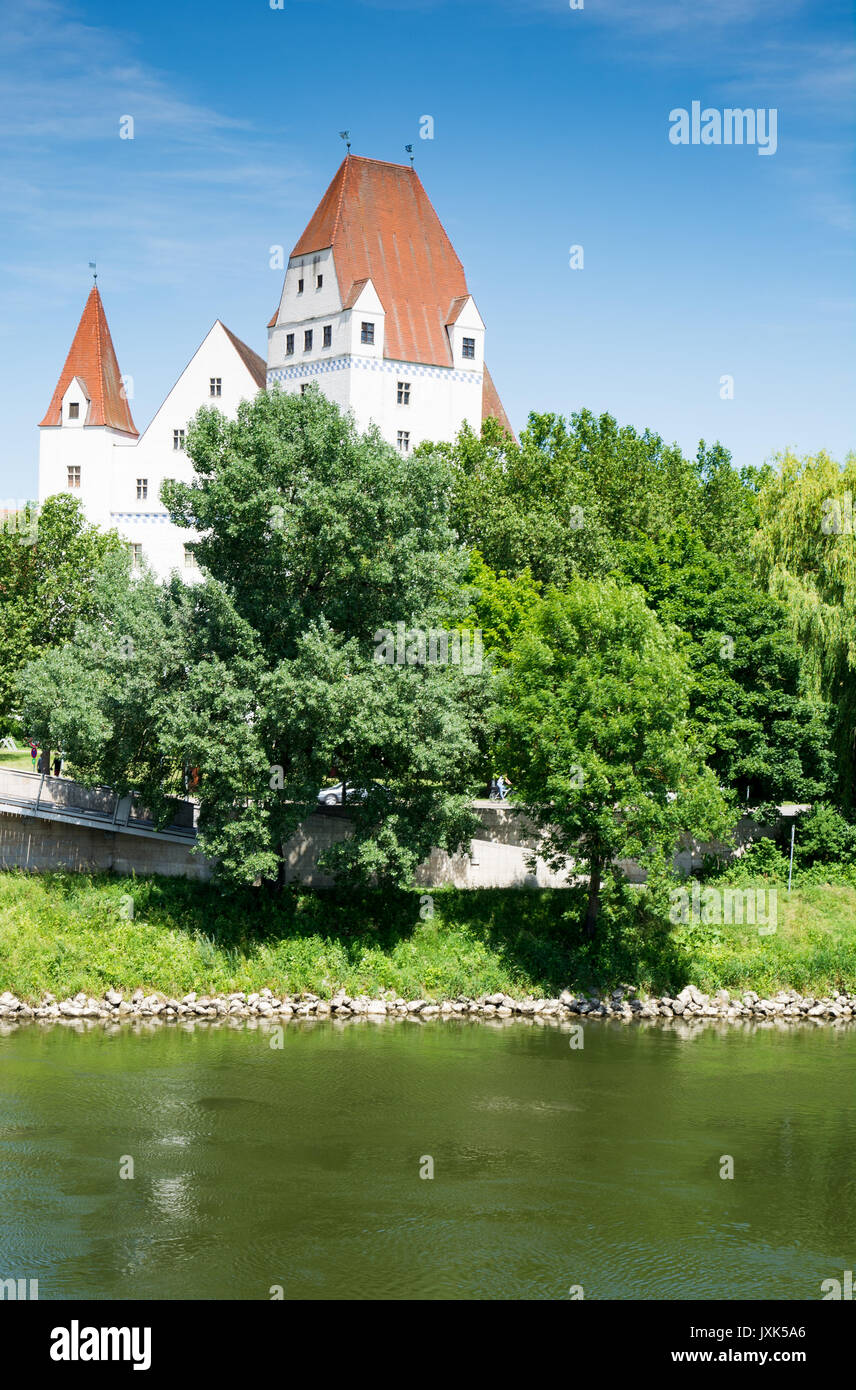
{"left": 267, "top": 153, "right": 510, "bottom": 453}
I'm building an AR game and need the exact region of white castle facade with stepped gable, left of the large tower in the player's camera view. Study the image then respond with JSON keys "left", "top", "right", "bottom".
{"left": 39, "top": 320, "right": 264, "bottom": 581}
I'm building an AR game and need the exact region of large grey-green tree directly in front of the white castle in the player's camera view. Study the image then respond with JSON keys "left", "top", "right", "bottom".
{"left": 24, "top": 389, "right": 489, "bottom": 885}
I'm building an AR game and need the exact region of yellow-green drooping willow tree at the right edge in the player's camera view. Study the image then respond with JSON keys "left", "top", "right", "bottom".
{"left": 756, "top": 450, "right": 856, "bottom": 808}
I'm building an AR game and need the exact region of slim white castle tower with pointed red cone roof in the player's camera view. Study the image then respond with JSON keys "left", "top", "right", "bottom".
{"left": 39, "top": 285, "right": 139, "bottom": 525}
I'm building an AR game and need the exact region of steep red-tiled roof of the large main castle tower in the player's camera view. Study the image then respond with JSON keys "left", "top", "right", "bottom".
{"left": 292, "top": 154, "right": 468, "bottom": 367}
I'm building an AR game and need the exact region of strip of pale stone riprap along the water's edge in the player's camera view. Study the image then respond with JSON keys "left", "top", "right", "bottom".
{"left": 0, "top": 984, "right": 856, "bottom": 1027}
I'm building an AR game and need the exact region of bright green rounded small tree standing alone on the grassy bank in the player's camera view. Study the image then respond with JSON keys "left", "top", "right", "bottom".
{"left": 495, "top": 580, "right": 727, "bottom": 937}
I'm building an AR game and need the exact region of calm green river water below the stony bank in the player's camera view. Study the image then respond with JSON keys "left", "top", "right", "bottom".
{"left": 0, "top": 1023, "right": 856, "bottom": 1300}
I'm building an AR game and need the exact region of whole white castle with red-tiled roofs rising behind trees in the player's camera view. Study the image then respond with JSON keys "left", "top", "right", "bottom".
{"left": 39, "top": 153, "right": 510, "bottom": 580}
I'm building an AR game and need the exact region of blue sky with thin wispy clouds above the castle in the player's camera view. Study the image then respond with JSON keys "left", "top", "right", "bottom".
{"left": 0, "top": 0, "right": 856, "bottom": 498}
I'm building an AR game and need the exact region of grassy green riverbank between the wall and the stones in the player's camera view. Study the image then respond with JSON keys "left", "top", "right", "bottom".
{"left": 0, "top": 872, "right": 856, "bottom": 999}
